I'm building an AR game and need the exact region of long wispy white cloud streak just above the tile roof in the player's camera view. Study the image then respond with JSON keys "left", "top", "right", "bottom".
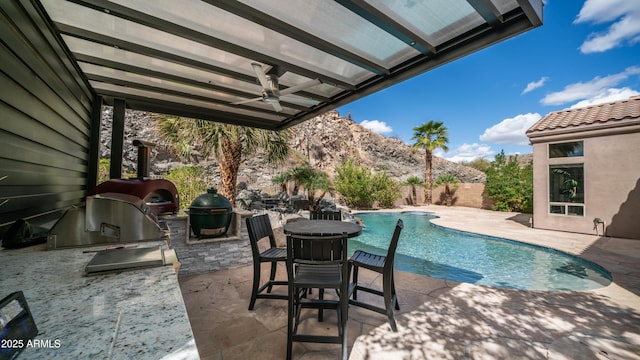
{"left": 540, "top": 66, "right": 640, "bottom": 105}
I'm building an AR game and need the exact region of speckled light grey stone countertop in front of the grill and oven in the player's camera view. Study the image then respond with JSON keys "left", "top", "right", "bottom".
{"left": 0, "top": 242, "right": 199, "bottom": 360}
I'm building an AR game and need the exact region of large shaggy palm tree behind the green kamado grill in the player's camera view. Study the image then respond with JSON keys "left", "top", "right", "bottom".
{"left": 156, "top": 116, "right": 290, "bottom": 205}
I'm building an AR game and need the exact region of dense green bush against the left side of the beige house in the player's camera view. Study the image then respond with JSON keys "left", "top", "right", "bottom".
{"left": 485, "top": 150, "right": 533, "bottom": 213}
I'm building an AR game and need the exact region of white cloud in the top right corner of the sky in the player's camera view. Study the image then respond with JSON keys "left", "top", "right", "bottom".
{"left": 574, "top": 0, "right": 640, "bottom": 54}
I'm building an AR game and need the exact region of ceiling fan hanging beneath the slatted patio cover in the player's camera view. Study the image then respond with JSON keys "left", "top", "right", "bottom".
{"left": 232, "top": 63, "right": 322, "bottom": 112}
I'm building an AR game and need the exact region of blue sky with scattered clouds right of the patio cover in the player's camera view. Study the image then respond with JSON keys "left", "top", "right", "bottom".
{"left": 337, "top": 0, "right": 640, "bottom": 161}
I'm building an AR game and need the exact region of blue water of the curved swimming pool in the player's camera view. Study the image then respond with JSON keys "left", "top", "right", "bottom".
{"left": 349, "top": 212, "right": 611, "bottom": 291}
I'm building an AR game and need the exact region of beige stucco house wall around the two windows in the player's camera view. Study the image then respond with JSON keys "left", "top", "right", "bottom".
{"left": 533, "top": 129, "right": 640, "bottom": 239}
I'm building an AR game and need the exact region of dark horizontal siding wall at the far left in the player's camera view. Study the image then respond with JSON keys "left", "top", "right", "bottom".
{"left": 0, "top": 0, "right": 93, "bottom": 235}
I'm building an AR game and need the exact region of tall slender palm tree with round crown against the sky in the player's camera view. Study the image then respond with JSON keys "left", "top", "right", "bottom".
{"left": 411, "top": 120, "right": 449, "bottom": 205}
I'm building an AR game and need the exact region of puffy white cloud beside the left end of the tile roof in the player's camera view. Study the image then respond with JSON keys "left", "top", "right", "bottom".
{"left": 480, "top": 113, "right": 542, "bottom": 145}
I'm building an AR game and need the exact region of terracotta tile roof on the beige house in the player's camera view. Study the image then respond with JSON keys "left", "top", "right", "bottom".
{"left": 527, "top": 96, "right": 640, "bottom": 134}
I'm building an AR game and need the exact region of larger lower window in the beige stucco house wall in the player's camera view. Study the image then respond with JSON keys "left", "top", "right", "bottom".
{"left": 549, "top": 164, "right": 584, "bottom": 216}
